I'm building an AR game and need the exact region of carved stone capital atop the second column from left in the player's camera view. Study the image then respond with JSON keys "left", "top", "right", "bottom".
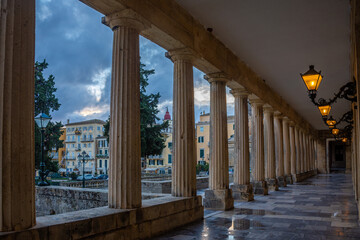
{"left": 101, "top": 9, "right": 151, "bottom": 32}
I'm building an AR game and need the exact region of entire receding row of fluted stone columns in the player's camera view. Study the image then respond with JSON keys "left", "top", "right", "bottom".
{"left": 0, "top": 5, "right": 320, "bottom": 231}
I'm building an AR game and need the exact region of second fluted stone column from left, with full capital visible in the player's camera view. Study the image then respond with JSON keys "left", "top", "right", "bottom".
{"left": 103, "top": 9, "right": 146, "bottom": 209}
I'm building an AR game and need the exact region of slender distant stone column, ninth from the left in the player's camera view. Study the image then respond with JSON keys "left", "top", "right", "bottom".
{"left": 283, "top": 117, "right": 295, "bottom": 184}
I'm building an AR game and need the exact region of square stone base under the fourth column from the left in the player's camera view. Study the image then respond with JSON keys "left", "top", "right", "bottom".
{"left": 203, "top": 189, "right": 234, "bottom": 210}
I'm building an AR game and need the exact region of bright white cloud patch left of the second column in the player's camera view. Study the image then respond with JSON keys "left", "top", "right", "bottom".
{"left": 87, "top": 67, "right": 111, "bottom": 102}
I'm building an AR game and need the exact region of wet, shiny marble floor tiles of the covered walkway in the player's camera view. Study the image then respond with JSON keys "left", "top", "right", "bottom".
{"left": 154, "top": 173, "right": 360, "bottom": 240}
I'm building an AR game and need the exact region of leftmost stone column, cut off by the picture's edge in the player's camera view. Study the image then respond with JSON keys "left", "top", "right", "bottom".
{"left": 0, "top": 0, "right": 36, "bottom": 232}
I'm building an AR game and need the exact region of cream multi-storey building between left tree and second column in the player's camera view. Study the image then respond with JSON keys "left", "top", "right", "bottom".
{"left": 65, "top": 119, "right": 105, "bottom": 174}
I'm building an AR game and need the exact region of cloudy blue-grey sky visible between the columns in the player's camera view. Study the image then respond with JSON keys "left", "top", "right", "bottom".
{"left": 35, "top": 0, "right": 234, "bottom": 124}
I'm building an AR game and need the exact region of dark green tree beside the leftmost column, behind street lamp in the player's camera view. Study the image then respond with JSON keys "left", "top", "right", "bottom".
{"left": 35, "top": 59, "right": 64, "bottom": 172}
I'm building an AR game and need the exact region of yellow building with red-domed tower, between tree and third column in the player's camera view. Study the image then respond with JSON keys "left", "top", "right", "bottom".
{"left": 145, "top": 110, "right": 172, "bottom": 173}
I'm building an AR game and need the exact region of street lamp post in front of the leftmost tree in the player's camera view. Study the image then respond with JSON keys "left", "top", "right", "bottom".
{"left": 35, "top": 113, "right": 51, "bottom": 186}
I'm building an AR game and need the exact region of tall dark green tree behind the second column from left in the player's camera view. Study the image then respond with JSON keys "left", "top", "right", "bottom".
{"left": 104, "top": 63, "right": 168, "bottom": 157}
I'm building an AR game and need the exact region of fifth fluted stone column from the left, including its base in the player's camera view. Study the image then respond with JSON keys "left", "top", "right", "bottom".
{"left": 231, "top": 88, "right": 254, "bottom": 201}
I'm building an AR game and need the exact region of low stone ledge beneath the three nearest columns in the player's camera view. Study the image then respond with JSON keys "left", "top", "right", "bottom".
{"left": 0, "top": 196, "right": 204, "bottom": 240}
